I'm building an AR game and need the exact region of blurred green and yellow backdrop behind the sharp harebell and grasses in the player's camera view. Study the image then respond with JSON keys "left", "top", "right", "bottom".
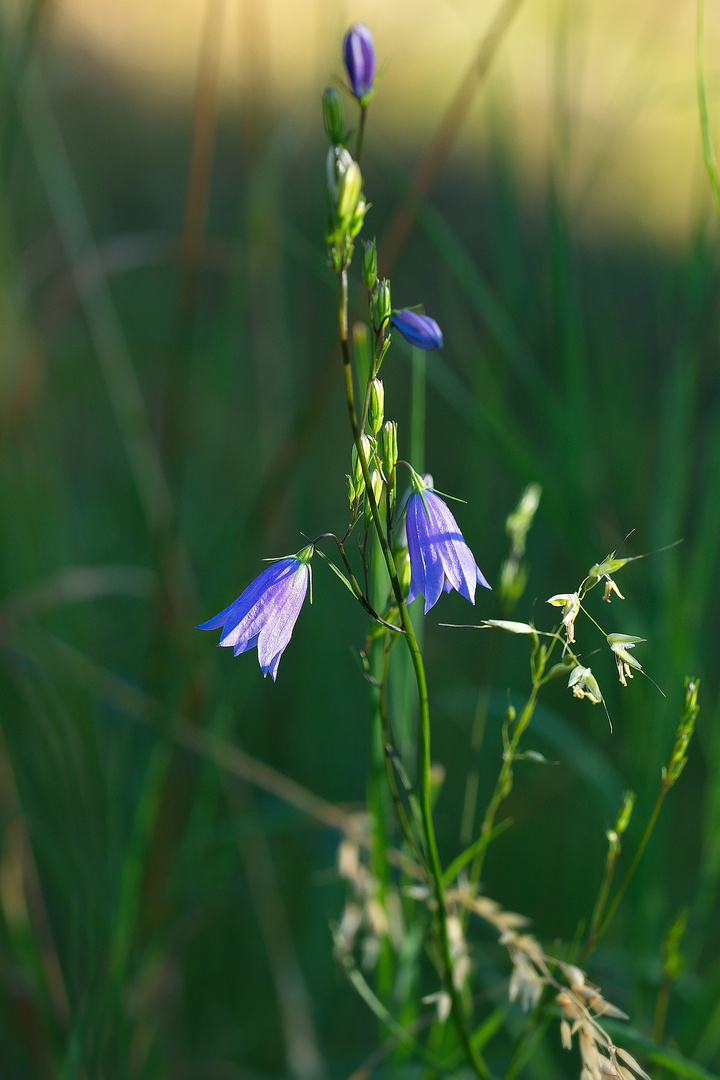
{"left": 0, "top": 0, "right": 720, "bottom": 1080}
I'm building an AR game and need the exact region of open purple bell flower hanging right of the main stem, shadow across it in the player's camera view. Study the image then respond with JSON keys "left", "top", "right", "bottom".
{"left": 405, "top": 488, "right": 490, "bottom": 615}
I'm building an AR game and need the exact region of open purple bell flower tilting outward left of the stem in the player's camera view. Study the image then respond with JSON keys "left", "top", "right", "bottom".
{"left": 195, "top": 546, "right": 313, "bottom": 681}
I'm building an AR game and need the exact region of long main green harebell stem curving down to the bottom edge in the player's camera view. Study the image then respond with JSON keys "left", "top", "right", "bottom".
{"left": 338, "top": 268, "right": 488, "bottom": 1078}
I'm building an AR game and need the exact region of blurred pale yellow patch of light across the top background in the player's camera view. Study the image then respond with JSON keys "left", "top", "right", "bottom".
{"left": 49, "top": 0, "right": 720, "bottom": 243}
